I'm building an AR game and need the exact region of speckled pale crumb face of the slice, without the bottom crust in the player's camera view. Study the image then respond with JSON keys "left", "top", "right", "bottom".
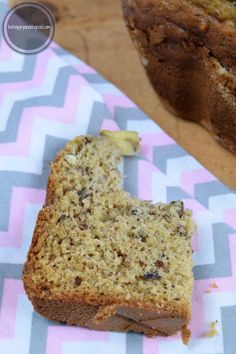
{"left": 24, "top": 133, "right": 195, "bottom": 304}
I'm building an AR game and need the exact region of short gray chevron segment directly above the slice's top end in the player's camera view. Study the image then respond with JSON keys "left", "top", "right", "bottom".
{"left": 87, "top": 102, "right": 111, "bottom": 135}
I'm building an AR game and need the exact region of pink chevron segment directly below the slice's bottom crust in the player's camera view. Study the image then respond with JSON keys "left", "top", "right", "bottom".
{"left": 46, "top": 326, "right": 109, "bottom": 354}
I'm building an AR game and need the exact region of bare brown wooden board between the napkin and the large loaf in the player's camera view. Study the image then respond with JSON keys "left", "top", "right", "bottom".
{"left": 8, "top": 0, "right": 236, "bottom": 189}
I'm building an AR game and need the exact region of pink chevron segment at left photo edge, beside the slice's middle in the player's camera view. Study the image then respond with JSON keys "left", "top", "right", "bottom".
{"left": 0, "top": 187, "right": 45, "bottom": 248}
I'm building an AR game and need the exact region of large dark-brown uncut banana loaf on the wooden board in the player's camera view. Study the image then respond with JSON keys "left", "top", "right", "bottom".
{"left": 122, "top": 0, "right": 236, "bottom": 152}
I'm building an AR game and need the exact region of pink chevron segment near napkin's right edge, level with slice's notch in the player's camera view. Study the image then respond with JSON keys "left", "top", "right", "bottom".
{"left": 181, "top": 168, "right": 216, "bottom": 196}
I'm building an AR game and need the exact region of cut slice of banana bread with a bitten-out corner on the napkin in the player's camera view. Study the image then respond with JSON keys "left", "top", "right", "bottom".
{"left": 23, "top": 131, "right": 195, "bottom": 341}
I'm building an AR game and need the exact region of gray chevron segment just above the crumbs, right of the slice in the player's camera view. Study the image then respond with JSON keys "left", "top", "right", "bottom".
{"left": 193, "top": 223, "right": 235, "bottom": 280}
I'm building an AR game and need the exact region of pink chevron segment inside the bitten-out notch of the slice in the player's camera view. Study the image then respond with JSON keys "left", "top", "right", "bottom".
{"left": 137, "top": 160, "right": 160, "bottom": 200}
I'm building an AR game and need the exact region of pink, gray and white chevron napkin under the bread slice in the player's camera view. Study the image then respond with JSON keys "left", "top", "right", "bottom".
{"left": 0, "top": 3, "right": 236, "bottom": 354}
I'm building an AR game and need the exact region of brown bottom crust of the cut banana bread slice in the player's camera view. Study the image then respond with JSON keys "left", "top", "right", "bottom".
{"left": 27, "top": 297, "right": 187, "bottom": 337}
